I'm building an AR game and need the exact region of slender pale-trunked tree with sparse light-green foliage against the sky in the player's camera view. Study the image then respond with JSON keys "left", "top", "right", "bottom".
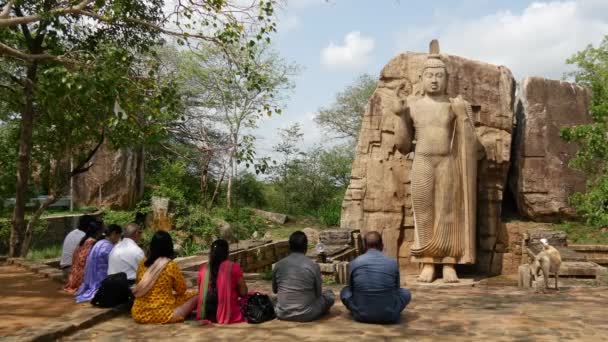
{"left": 166, "top": 44, "right": 296, "bottom": 208}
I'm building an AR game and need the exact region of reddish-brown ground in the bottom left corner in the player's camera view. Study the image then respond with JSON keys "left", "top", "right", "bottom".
{"left": 0, "top": 265, "right": 78, "bottom": 336}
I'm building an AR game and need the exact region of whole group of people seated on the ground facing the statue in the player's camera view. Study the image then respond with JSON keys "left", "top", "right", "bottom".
{"left": 61, "top": 218, "right": 411, "bottom": 324}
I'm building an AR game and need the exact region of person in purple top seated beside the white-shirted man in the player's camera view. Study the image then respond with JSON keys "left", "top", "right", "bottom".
{"left": 76, "top": 224, "right": 122, "bottom": 303}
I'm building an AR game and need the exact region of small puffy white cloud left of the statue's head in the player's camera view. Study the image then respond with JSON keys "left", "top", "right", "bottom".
{"left": 321, "top": 31, "right": 374, "bottom": 69}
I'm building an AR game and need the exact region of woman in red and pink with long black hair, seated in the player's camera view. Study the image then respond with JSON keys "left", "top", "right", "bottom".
{"left": 196, "top": 239, "right": 247, "bottom": 324}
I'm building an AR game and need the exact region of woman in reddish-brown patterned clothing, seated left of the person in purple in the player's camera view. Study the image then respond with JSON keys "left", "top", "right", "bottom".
{"left": 63, "top": 221, "right": 103, "bottom": 293}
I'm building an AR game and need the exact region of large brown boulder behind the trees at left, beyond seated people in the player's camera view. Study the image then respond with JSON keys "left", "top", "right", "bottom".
{"left": 74, "top": 143, "right": 144, "bottom": 209}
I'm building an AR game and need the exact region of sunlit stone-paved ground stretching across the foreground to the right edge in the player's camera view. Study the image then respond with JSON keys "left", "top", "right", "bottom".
{"left": 64, "top": 282, "right": 608, "bottom": 342}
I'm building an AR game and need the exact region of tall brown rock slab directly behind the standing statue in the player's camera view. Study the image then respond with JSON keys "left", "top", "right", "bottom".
{"left": 340, "top": 53, "right": 515, "bottom": 273}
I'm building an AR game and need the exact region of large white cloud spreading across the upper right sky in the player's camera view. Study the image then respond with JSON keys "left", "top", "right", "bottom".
{"left": 398, "top": 0, "right": 608, "bottom": 79}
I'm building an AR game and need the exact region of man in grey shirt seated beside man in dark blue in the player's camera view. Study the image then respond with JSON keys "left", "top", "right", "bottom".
{"left": 272, "top": 231, "right": 335, "bottom": 322}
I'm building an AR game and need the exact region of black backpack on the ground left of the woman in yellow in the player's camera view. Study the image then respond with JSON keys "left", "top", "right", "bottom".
{"left": 91, "top": 272, "right": 133, "bottom": 308}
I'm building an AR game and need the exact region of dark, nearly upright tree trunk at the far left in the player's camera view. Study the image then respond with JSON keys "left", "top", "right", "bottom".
{"left": 9, "top": 63, "right": 37, "bottom": 257}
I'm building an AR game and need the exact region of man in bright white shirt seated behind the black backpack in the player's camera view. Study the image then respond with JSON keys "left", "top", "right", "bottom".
{"left": 108, "top": 223, "right": 144, "bottom": 284}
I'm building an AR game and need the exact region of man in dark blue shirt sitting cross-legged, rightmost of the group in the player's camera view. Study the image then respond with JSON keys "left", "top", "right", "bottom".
{"left": 340, "top": 231, "right": 412, "bottom": 323}
